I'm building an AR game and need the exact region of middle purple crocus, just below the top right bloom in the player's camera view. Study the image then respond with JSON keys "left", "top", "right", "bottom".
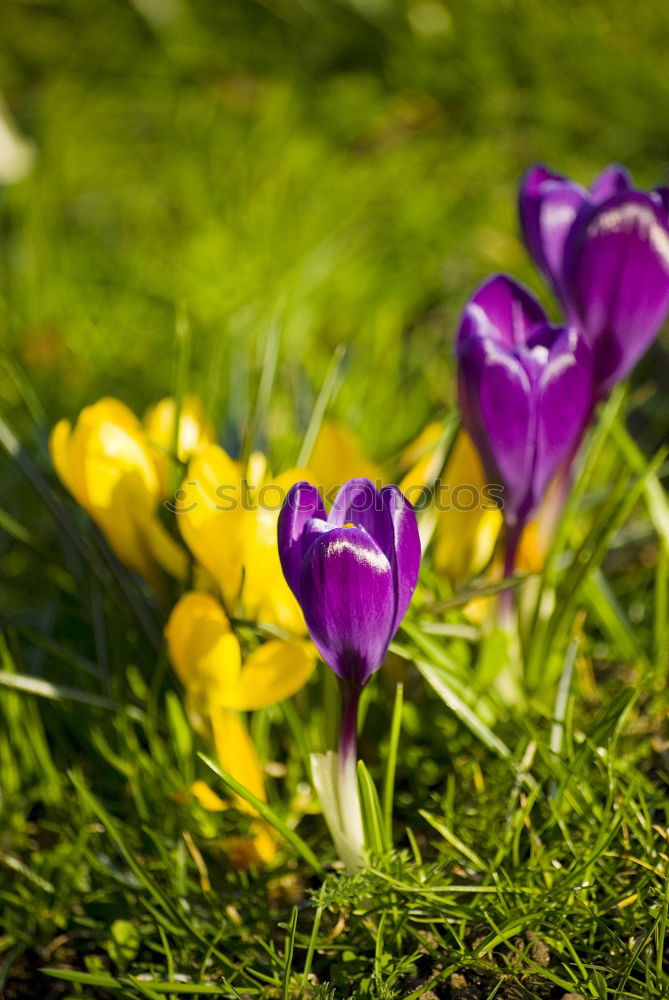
{"left": 456, "top": 275, "right": 592, "bottom": 572}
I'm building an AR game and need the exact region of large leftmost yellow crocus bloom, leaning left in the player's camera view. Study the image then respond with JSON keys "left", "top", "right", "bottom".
{"left": 49, "top": 397, "right": 187, "bottom": 584}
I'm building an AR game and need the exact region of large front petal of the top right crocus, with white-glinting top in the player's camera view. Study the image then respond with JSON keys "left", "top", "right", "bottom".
{"left": 564, "top": 193, "right": 669, "bottom": 396}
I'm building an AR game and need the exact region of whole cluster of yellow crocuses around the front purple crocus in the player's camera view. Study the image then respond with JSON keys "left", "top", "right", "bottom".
{"left": 50, "top": 396, "right": 540, "bottom": 861}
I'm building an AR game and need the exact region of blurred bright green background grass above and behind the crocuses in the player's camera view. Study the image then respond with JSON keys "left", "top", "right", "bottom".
{"left": 0, "top": 0, "right": 669, "bottom": 459}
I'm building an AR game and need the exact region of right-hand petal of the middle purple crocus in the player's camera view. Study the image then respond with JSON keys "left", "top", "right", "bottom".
{"left": 532, "top": 327, "right": 593, "bottom": 507}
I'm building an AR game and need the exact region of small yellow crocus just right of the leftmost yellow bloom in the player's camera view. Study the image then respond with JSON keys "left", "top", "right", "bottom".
{"left": 144, "top": 395, "right": 216, "bottom": 497}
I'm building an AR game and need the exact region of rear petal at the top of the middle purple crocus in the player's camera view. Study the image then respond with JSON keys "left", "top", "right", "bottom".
{"left": 456, "top": 274, "right": 546, "bottom": 350}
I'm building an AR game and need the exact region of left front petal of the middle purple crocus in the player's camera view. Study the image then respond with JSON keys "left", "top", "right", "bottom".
{"left": 458, "top": 336, "right": 535, "bottom": 523}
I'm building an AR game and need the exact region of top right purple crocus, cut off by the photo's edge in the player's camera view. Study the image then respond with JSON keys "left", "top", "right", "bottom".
{"left": 519, "top": 165, "right": 669, "bottom": 398}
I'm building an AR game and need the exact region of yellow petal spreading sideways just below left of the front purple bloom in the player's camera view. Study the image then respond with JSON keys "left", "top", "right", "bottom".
{"left": 235, "top": 639, "right": 316, "bottom": 711}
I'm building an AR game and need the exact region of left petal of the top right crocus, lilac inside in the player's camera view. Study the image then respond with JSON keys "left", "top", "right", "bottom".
{"left": 518, "top": 166, "right": 590, "bottom": 296}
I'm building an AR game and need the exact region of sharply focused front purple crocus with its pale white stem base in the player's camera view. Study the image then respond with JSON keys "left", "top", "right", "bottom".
{"left": 278, "top": 479, "right": 420, "bottom": 869}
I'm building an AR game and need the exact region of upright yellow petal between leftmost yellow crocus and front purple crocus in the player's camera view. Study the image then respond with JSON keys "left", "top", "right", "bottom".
{"left": 176, "top": 444, "right": 245, "bottom": 607}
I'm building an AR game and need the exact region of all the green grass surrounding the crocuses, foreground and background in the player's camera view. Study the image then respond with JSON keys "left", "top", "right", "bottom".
{"left": 0, "top": 0, "right": 669, "bottom": 1000}
